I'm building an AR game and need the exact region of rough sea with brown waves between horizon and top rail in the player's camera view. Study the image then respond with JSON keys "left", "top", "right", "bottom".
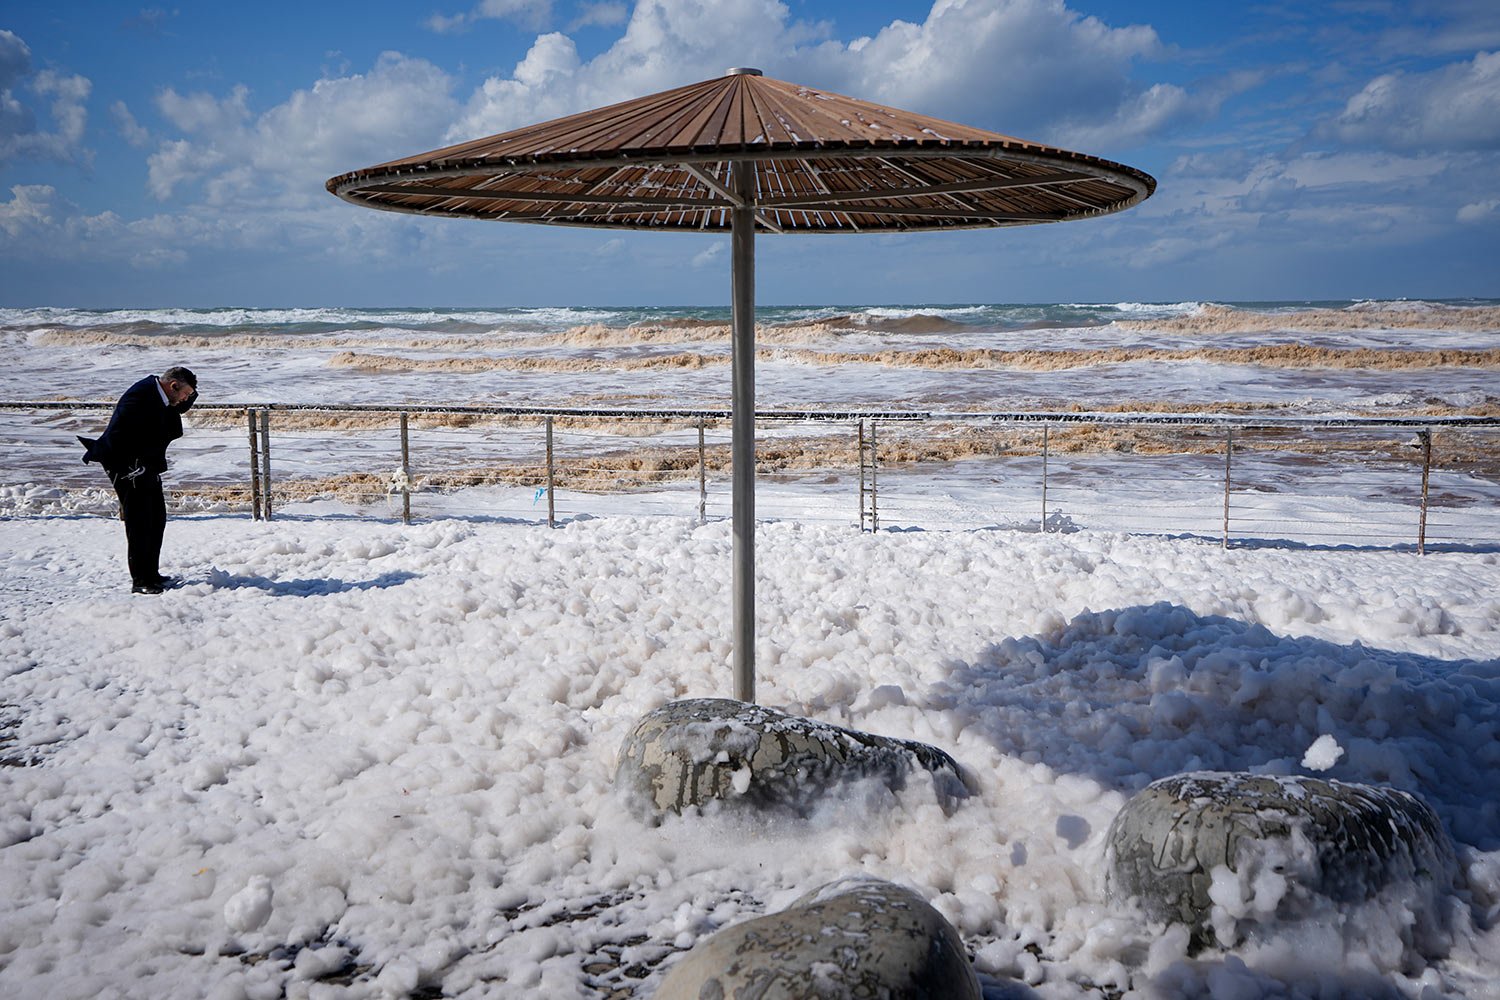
{"left": 11, "top": 300, "right": 1500, "bottom": 412}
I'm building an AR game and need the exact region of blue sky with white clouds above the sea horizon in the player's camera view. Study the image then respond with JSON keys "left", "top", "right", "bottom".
{"left": 0, "top": 0, "right": 1500, "bottom": 306}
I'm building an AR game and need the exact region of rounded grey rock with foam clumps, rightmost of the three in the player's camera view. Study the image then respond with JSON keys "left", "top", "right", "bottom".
{"left": 1107, "top": 771, "right": 1455, "bottom": 948}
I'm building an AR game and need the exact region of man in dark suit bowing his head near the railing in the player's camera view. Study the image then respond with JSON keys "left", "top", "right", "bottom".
{"left": 78, "top": 367, "right": 198, "bottom": 594}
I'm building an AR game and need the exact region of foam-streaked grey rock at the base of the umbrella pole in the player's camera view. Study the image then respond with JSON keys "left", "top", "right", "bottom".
{"left": 615, "top": 699, "right": 966, "bottom": 816}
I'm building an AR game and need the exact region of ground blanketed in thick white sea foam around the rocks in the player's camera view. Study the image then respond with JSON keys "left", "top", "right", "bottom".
{"left": 0, "top": 516, "right": 1500, "bottom": 1000}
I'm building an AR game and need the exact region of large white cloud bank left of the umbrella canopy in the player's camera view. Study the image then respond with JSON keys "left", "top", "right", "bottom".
{"left": 0, "top": 54, "right": 486, "bottom": 274}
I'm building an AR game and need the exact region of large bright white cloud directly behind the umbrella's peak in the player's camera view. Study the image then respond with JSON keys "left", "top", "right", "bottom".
{"left": 449, "top": 0, "right": 1182, "bottom": 148}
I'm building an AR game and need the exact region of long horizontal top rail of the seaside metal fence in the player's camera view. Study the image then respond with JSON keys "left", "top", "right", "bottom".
{"left": 0, "top": 400, "right": 1500, "bottom": 429}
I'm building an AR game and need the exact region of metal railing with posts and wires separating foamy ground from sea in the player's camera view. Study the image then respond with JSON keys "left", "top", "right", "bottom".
{"left": 0, "top": 400, "right": 1500, "bottom": 552}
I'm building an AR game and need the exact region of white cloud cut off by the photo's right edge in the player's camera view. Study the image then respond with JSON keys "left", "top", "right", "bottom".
{"left": 1320, "top": 52, "right": 1500, "bottom": 150}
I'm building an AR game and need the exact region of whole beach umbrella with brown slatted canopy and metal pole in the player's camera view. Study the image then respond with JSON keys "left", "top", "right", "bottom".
{"left": 327, "top": 69, "right": 1157, "bottom": 702}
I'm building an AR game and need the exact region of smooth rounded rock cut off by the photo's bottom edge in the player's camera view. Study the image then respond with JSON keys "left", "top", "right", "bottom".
{"left": 656, "top": 879, "right": 980, "bottom": 1000}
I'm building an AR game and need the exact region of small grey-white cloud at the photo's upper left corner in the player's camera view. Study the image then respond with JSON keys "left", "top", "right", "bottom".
{"left": 0, "top": 30, "right": 93, "bottom": 162}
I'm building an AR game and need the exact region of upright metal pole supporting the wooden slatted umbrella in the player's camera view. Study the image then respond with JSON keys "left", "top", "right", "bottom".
{"left": 729, "top": 160, "right": 755, "bottom": 702}
